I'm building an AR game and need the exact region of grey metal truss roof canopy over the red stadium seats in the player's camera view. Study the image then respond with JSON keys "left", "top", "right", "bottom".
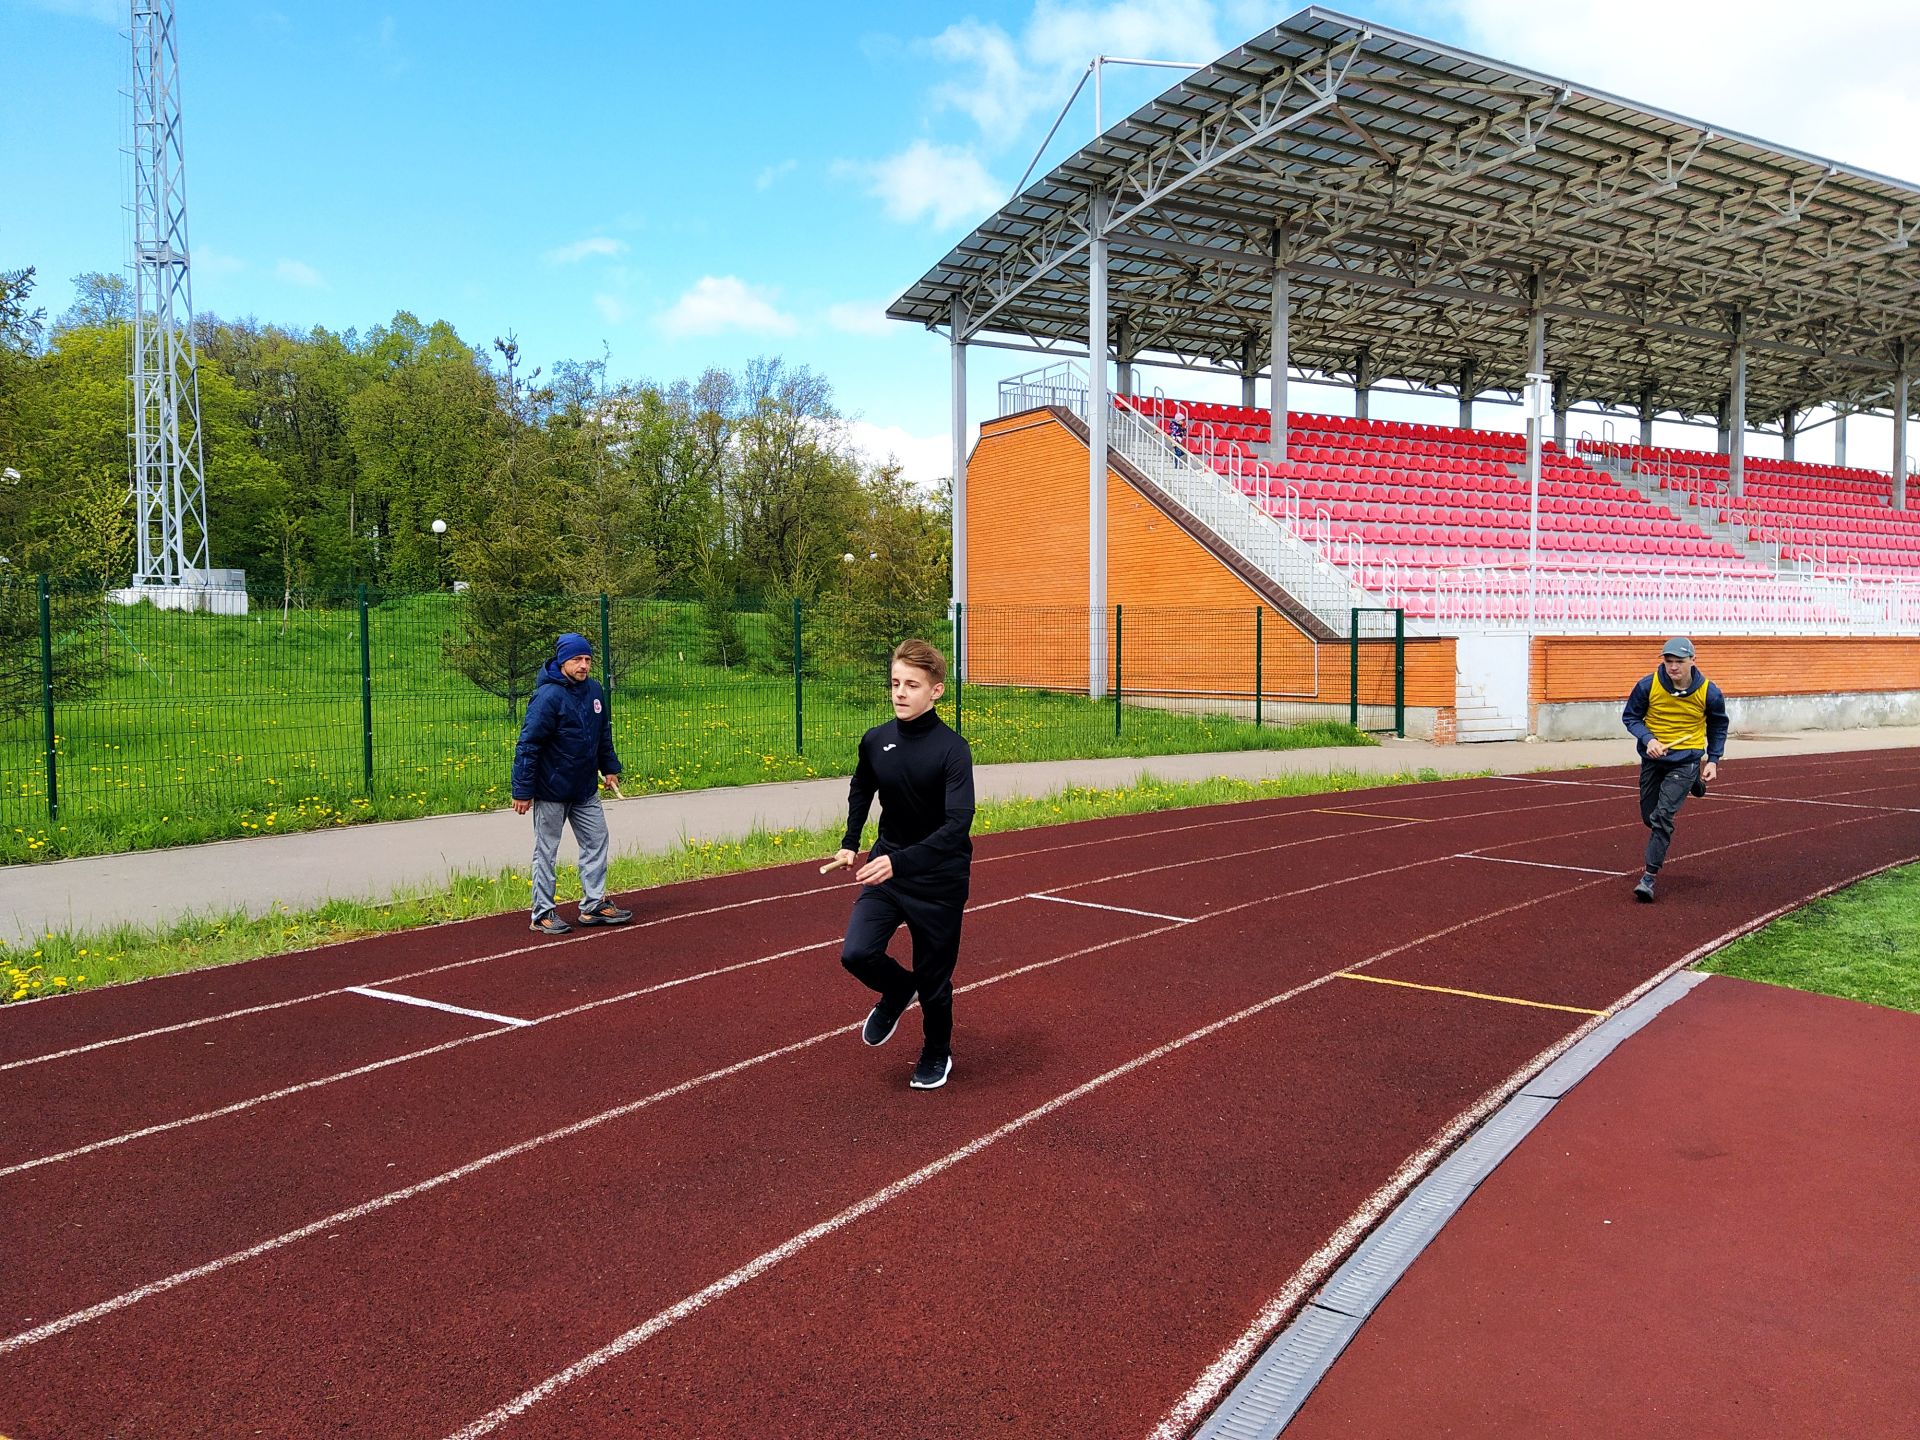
{"left": 887, "top": 8, "right": 1920, "bottom": 422}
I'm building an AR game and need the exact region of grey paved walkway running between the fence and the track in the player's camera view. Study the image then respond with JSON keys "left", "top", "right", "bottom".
{"left": 0, "top": 726, "right": 1920, "bottom": 945}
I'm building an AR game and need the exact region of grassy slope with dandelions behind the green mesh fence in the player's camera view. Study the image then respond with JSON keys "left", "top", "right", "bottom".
{"left": 0, "top": 595, "right": 1371, "bottom": 864}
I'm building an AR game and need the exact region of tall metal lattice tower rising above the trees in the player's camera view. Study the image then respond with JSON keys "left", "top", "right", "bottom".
{"left": 131, "top": 0, "right": 207, "bottom": 588}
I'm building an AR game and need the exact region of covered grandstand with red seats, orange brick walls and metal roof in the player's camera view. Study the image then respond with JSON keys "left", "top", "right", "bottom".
{"left": 889, "top": 8, "right": 1920, "bottom": 739}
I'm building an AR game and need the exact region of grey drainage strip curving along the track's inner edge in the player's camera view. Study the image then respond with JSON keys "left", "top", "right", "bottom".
{"left": 1192, "top": 970, "right": 1709, "bottom": 1440}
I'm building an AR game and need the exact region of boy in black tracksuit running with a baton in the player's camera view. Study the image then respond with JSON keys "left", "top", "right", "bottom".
{"left": 837, "top": 639, "right": 973, "bottom": 1091}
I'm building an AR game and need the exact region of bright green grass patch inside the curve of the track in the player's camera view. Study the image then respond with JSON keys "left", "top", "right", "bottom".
{"left": 1699, "top": 866, "right": 1920, "bottom": 1014}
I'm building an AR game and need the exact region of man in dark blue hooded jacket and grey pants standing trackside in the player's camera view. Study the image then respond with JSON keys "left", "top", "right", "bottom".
{"left": 513, "top": 634, "right": 634, "bottom": 935}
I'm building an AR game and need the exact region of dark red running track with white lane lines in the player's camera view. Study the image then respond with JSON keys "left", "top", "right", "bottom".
{"left": 0, "top": 753, "right": 1920, "bottom": 1440}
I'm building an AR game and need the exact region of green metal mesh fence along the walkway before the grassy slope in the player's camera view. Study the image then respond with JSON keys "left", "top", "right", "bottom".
{"left": 0, "top": 572, "right": 1374, "bottom": 862}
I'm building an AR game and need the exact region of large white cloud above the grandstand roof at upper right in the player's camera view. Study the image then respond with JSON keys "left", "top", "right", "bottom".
{"left": 1444, "top": 0, "right": 1920, "bottom": 179}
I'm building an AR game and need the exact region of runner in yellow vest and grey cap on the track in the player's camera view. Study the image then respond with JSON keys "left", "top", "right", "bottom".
{"left": 1620, "top": 636, "right": 1726, "bottom": 904}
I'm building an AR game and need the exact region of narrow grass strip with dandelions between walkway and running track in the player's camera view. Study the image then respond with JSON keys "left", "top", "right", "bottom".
{"left": 0, "top": 770, "right": 1442, "bottom": 1004}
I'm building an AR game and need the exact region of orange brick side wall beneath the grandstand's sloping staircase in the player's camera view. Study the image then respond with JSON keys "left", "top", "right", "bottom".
{"left": 966, "top": 413, "right": 1453, "bottom": 707}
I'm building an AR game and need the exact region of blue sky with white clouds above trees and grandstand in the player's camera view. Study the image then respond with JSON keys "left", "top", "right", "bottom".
{"left": 0, "top": 0, "right": 1920, "bottom": 478}
